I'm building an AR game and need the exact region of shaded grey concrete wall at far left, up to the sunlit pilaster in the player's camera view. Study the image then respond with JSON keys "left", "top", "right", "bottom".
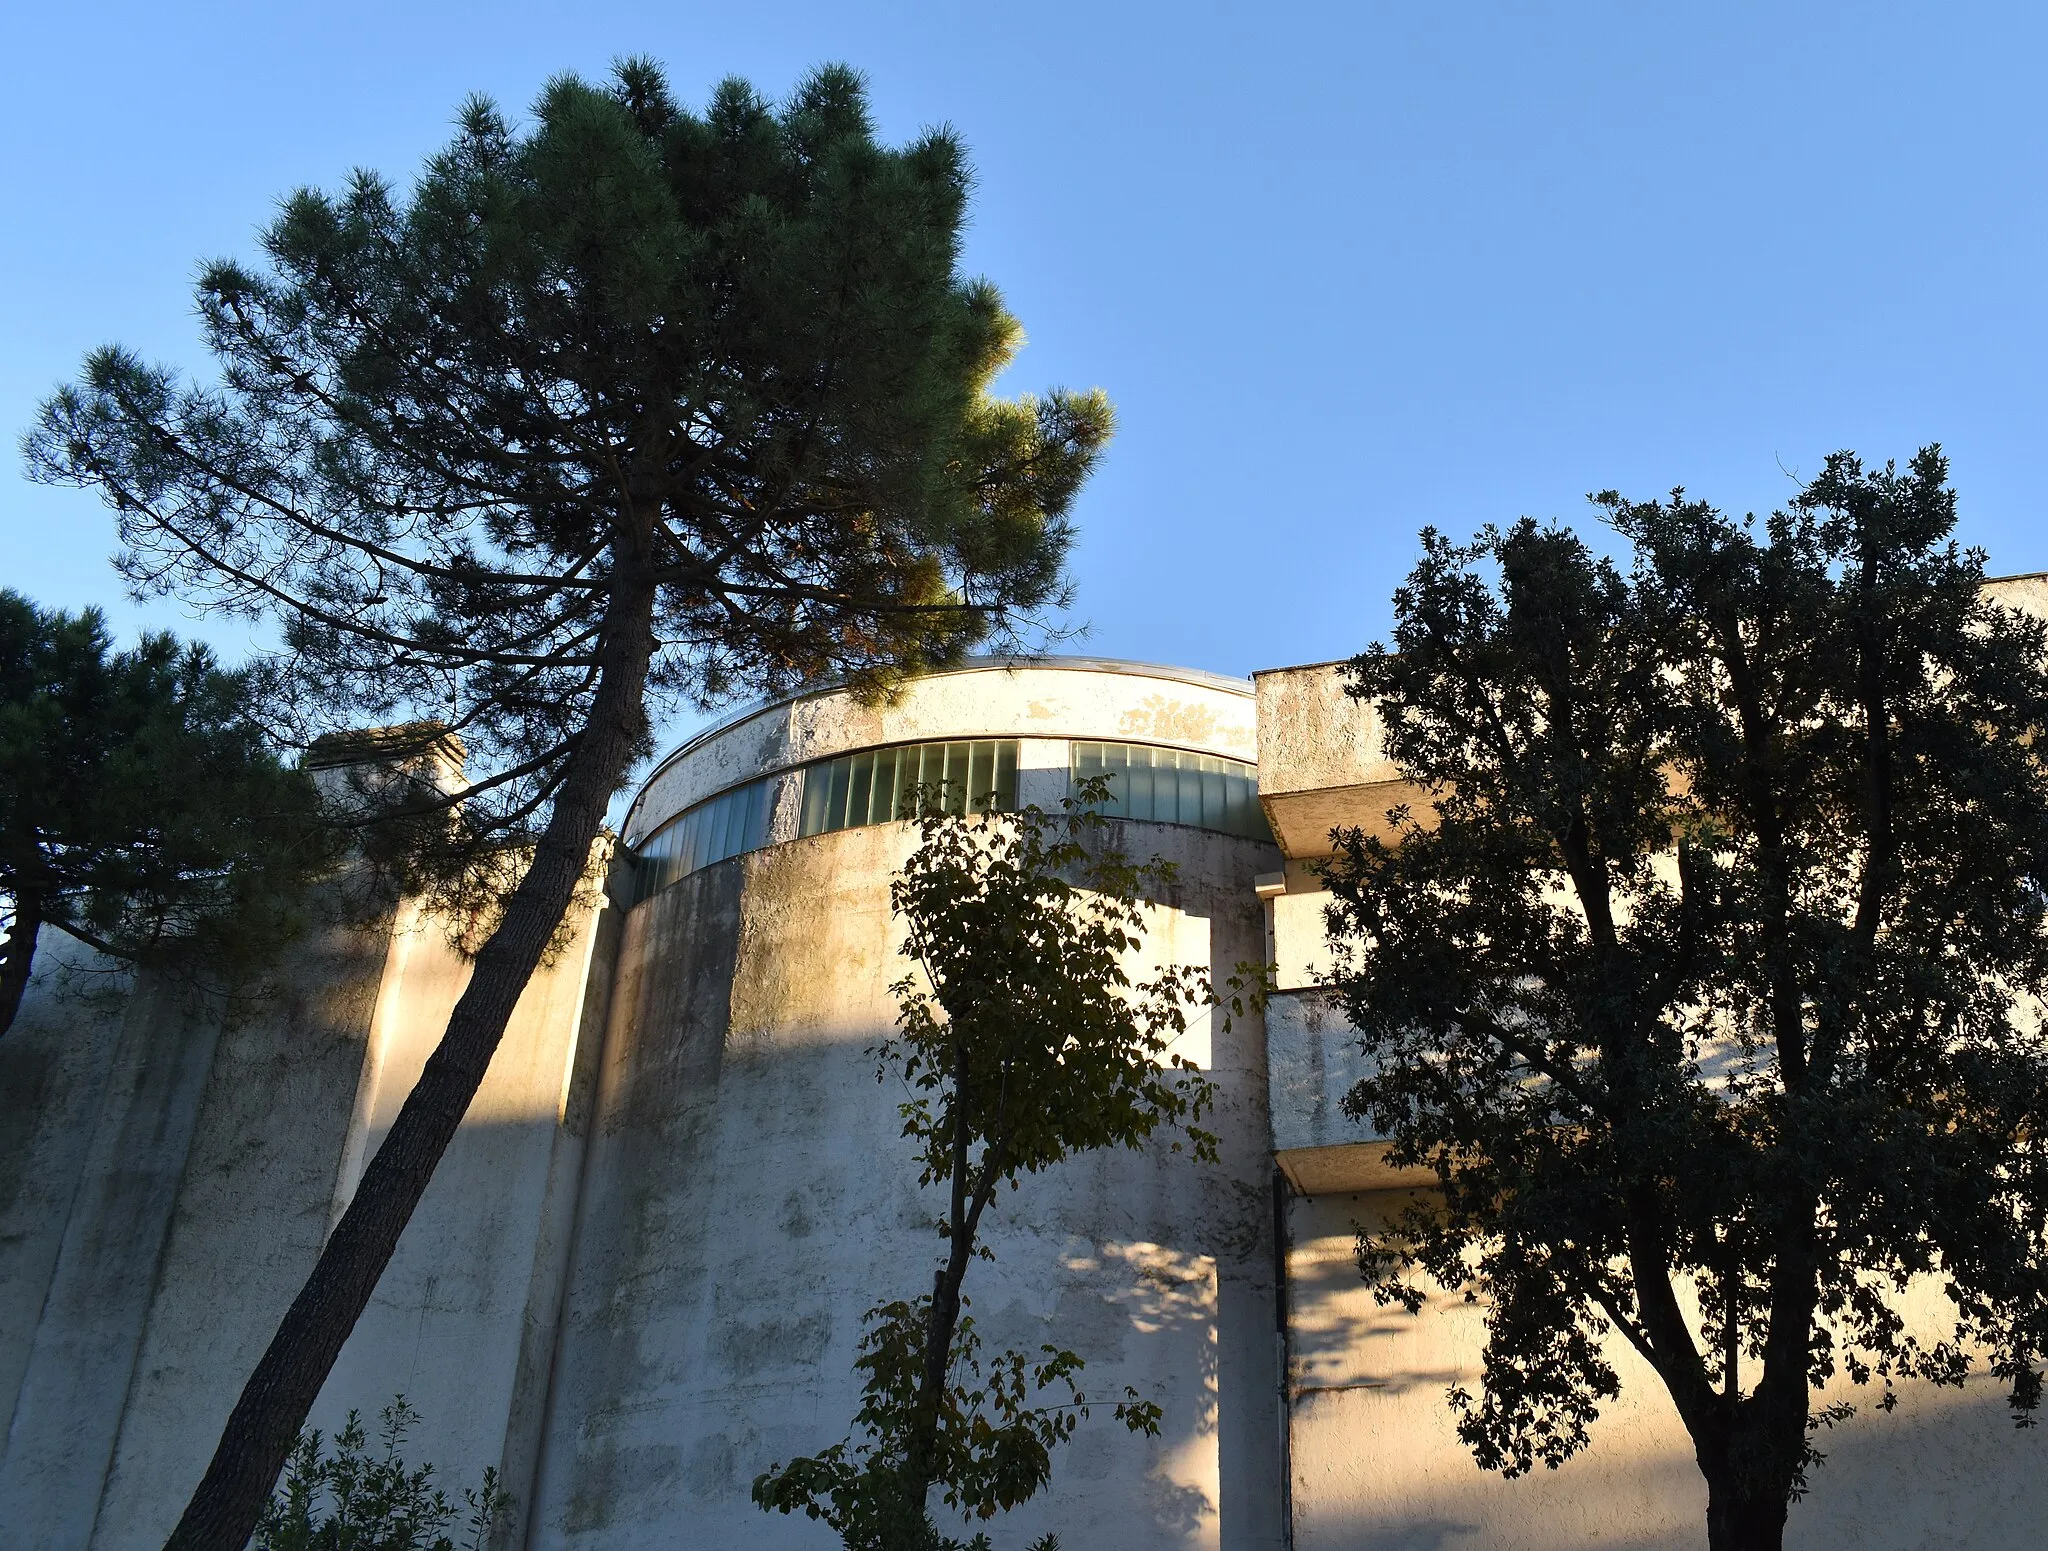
{"left": 0, "top": 897, "right": 395, "bottom": 1547}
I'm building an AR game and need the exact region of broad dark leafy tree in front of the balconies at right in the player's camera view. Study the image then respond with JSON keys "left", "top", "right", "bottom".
{"left": 1329, "top": 449, "right": 2048, "bottom": 1551}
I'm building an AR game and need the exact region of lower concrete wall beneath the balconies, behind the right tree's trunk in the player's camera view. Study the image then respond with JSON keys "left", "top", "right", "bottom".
{"left": 1286, "top": 1194, "right": 2048, "bottom": 1551}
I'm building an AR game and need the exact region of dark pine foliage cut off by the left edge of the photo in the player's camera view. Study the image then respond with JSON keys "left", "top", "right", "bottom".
{"left": 0, "top": 590, "right": 336, "bottom": 1033}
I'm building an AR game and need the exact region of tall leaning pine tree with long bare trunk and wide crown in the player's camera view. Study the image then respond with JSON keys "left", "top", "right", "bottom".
{"left": 29, "top": 61, "right": 1110, "bottom": 1551}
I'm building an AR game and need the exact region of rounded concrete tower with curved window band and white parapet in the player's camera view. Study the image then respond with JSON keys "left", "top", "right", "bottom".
{"left": 530, "top": 658, "right": 1282, "bottom": 1551}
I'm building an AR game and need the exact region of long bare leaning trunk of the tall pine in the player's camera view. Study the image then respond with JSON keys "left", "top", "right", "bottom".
{"left": 166, "top": 580, "right": 653, "bottom": 1551}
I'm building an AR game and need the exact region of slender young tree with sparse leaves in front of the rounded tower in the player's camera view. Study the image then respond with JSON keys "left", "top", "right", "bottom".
{"left": 754, "top": 781, "right": 1236, "bottom": 1551}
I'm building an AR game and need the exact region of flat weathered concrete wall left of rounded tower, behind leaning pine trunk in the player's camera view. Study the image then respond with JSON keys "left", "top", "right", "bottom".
{"left": 0, "top": 864, "right": 612, "bottom": 1551}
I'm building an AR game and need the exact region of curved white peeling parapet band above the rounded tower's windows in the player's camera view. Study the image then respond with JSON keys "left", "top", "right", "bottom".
{"left": 623, "top": 658, "right": 1257, "bottom": 844}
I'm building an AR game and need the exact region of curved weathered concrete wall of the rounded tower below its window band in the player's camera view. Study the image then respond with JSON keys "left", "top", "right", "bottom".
{"left": 535, "top": 824, "right": 1280, "bottom": 1551}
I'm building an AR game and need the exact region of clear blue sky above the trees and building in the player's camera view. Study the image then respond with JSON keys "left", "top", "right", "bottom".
{"left": 0, "top": 0, "right": 2048, "bottom": 749}
